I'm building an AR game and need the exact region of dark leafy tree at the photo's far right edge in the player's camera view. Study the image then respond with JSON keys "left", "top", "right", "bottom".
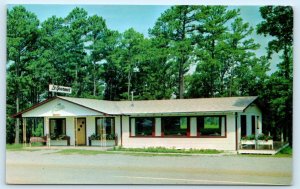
{"left": 257, "top": 6, "right": 293, "bottom": 144}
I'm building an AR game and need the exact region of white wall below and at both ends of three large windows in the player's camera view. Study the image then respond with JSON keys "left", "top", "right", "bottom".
{"left": 122, "top": 113, "right": 236, "bottom": 150}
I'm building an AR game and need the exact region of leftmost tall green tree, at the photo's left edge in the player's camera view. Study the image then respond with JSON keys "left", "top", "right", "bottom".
{"left": 7, "top": 6, "right": 39, "bottom": 143}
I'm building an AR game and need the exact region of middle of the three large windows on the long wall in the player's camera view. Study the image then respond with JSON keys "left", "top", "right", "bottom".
{"left": 161, "top": 117, "right": 188, "bottom": 136}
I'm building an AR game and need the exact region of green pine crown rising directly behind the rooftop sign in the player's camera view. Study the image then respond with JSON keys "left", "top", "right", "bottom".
{"left": 37, "top": 16, "right": 70, "bottom": 98}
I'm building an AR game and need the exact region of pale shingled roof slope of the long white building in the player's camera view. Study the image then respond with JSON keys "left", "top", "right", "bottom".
{"left": 58, "top": 96, "right": 257, "bottom": 115}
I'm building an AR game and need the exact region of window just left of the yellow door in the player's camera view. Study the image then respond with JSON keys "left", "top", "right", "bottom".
{"left": 49, "top": 118, "right": 66, "bottom": 139}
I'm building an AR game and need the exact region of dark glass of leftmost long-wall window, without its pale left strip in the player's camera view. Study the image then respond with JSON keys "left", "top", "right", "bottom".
{"left": 134, "top": 117, "right": 154, "bottom": 136}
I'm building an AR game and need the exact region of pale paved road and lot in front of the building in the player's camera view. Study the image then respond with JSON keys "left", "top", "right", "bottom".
{"left": 6, "top": 150, "right": 292, "bottom": 185}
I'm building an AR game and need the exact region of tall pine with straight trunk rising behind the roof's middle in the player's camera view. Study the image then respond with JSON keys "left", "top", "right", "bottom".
{"left": 150, "top": 6, "right": 196, "bottom": 99}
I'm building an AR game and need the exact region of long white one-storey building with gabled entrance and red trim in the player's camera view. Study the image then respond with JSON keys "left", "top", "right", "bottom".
{"left": 13, "top": 96, "right": 262, "bottom": 151}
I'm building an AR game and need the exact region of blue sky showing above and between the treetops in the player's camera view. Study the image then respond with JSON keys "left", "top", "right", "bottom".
{"left": 8, "top": 4, "right": 279, "bottom": 73}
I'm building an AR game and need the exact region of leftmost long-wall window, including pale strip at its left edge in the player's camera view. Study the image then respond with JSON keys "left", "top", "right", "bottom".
{"left": 130, "top": 117, "right": 155, "bottom": 136}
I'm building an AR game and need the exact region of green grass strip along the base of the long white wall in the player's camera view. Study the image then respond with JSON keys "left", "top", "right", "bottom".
{"left": 113, "top": 147, "right": 223, "bottom": 154}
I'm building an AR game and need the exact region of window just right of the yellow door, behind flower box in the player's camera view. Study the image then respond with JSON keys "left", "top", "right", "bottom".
{"left": 96, "top": 117, "right": 115, "bottom": 135}
